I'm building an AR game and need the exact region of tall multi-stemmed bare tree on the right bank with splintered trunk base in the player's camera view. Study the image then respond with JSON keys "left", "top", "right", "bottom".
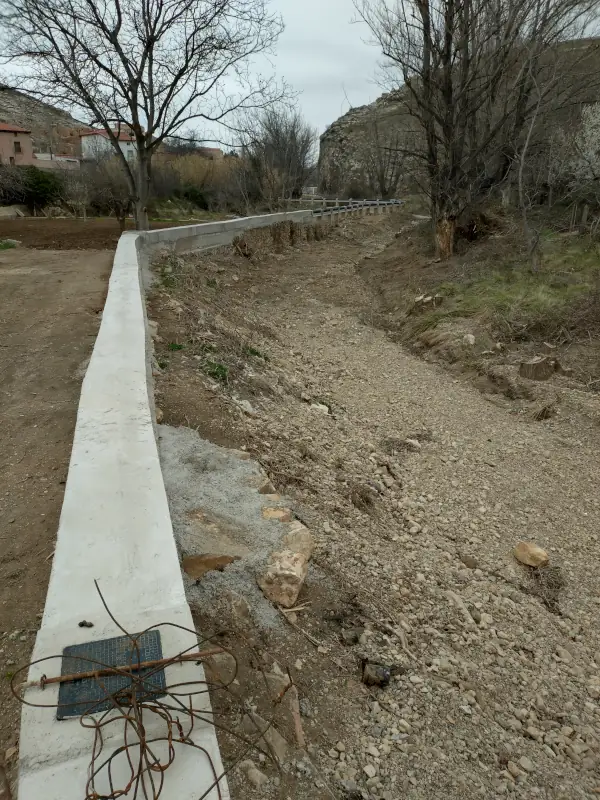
{"left": 354, "top": 0, "right": 597, "bottom": 257}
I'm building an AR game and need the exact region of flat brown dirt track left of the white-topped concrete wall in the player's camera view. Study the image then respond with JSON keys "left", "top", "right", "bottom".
{"left": 0, "top": 249, "right": 112, "bottom": 766}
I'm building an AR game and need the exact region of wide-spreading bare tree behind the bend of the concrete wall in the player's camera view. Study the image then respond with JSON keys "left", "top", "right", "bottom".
{"left": 0, "top": 0, "right": 284, "bottom": 229}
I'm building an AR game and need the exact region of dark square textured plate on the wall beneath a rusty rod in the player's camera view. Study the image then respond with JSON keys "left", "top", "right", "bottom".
{"left": 56, "top": 631, "right": 166, "bottom": 719}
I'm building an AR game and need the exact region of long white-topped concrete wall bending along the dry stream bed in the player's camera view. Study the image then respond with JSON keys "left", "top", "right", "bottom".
{"left": 19, "top": 208, "right": 394, "bottom": 800}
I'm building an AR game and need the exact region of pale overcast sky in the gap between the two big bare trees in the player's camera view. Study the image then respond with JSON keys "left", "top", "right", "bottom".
{"left": 271, "top": 0, "right": 382, "bottom": 133}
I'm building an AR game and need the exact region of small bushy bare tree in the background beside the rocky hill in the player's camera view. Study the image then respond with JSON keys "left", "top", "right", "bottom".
{"left": 241, "top": 106, "right": 317, "bottom": 206}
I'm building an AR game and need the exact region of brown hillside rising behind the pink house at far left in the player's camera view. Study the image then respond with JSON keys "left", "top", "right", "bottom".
{"left": 0, "top": 84, "right": 89, "bottom": 156}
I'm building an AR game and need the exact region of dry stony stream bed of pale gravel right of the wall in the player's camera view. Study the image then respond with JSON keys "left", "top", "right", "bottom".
{"left": 153, "top": 216, "right": 600, "bottom": 800}
